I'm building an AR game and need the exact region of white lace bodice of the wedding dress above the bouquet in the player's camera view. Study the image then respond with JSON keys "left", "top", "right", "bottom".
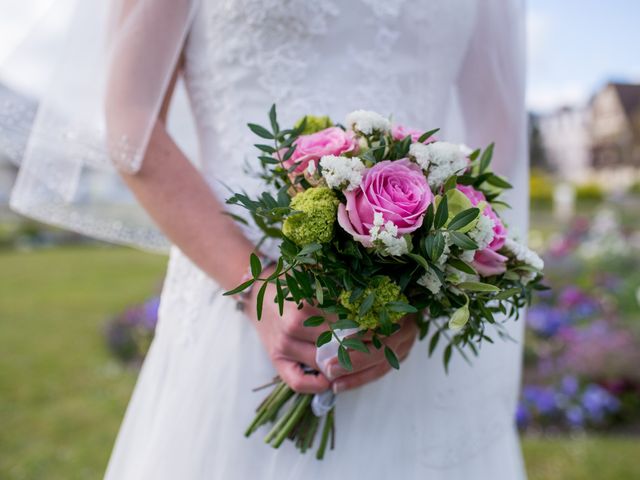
{"left": 185, "top": 0, "right": 475, "bottom": 255}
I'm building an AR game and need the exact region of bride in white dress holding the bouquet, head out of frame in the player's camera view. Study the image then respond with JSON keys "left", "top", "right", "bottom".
{"left": 3, "top": 0, "right": 528, "bottom": 480}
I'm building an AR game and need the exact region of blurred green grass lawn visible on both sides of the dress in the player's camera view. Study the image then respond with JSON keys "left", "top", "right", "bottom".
{"left": 0, "top": 247, "right": 640, "bottom": 480}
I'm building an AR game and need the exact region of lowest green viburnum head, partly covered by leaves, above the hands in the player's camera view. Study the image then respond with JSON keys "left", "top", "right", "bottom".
{"left": 338, "top": 276, "right": 407, "bottom": 329}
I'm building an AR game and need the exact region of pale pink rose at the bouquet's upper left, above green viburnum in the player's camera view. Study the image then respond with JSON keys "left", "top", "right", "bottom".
{"left": 284, "top": 127, "right": 358, "bottom": 173}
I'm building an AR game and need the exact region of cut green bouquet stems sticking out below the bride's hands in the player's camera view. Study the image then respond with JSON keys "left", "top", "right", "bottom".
{"left": 245, "top": 380, "right": 335, "bottom": 460}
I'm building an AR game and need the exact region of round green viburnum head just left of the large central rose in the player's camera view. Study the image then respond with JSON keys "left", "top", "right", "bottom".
{"left": 282, "top": 187, "right": 340, "bottom": 245}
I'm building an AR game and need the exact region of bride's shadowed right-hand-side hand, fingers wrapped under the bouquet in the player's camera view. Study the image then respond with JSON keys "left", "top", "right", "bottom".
{"left": 327, "top": 317, "right": 418, "bottom": 393}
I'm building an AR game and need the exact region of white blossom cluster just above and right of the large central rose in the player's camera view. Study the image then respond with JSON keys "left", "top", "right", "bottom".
{"left": 409, "top": 142, "right": 468, "bottom": 189}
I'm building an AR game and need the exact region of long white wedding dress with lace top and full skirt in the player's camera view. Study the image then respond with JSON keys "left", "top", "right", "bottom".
{"left": 106, "top": 0, "right": 527, "bottom": 480}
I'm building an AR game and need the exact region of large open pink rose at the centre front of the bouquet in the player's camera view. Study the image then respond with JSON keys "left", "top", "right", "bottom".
{"left": 338, "top": 158, "right": 433, "bottom": 247}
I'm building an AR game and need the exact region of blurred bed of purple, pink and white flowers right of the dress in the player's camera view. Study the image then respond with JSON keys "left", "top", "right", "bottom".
{"left": 516, "top": 209, "right": 640, "bottom": 430}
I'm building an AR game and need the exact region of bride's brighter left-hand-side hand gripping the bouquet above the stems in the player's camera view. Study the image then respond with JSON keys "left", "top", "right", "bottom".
{"left": 247, "top": 269, "right": 331, "bottom": 393}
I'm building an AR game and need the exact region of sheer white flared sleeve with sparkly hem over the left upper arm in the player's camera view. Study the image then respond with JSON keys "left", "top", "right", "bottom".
{"left": 0, "top": 0, "right": 198, "bottom": 251}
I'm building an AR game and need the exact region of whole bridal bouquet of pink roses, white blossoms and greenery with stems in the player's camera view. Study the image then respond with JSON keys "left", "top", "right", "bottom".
{"left": 226, "top": 106, "right": 544, "bottom": 459}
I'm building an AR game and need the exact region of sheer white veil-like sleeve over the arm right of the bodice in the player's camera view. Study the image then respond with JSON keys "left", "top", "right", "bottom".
{"left": 458, "top": 0, "right": 529, "bottom": 237}
